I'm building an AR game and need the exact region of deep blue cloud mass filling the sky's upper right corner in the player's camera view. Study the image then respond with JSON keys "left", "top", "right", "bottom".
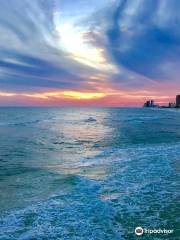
{"left": 106, "top": 0, "right": 180, "bottom": 80}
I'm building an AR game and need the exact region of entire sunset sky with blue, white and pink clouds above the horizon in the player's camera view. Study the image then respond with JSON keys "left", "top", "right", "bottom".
{"left": 0, "top": 0, "right": 180, "bottom": 106}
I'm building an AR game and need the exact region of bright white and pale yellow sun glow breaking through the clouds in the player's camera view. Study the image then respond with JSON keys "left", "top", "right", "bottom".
{"left": 56, "top": 22, "right": 116, "bottom": 72}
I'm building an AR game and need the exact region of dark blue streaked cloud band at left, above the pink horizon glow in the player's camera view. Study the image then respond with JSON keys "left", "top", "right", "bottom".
{"left": 0, "top": 52, "right": 85, "bottom": 88}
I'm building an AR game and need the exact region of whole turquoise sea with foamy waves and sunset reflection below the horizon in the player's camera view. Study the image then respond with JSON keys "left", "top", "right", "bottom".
{"left": 0, "top": 108, "right": 180, "bottom": 240}
